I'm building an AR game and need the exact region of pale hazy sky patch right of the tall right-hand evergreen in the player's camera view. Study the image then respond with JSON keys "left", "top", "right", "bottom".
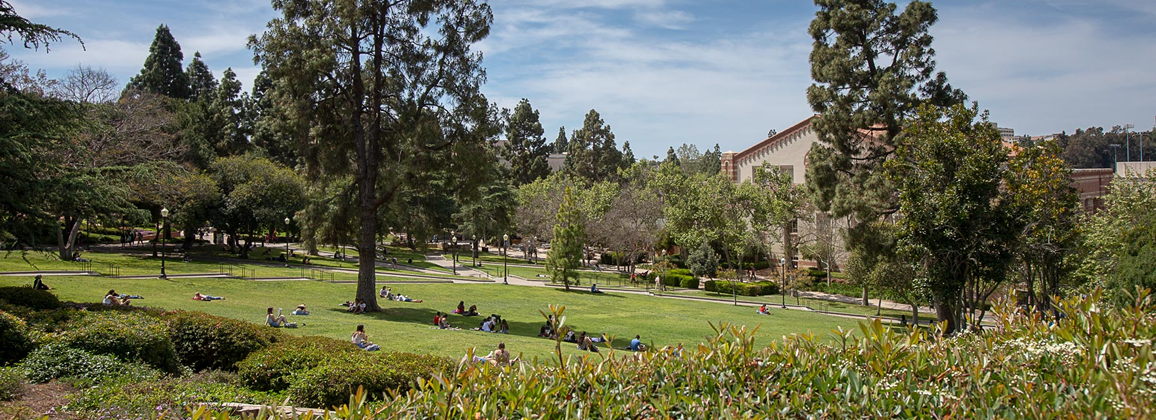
{"left": 933, "top": 3, "right": 1156, "bottom": 134}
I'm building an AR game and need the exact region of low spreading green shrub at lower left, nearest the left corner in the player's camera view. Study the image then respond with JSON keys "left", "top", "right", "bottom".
{"left": 20, "top": 344, "right": 160, "bottom": 383}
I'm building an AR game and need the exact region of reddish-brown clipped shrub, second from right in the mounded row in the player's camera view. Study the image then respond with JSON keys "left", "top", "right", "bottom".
{"left": 164, "top": 311, "right": 279, "bottom": 370}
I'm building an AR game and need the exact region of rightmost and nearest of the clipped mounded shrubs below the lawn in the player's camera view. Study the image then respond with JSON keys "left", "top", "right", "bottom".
{"left": 289, "top": 352, "right": 451, "bottom": 407}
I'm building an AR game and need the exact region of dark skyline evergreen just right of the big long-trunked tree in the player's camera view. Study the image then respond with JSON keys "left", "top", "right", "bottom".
{"left": 499, "top": 98, "right": 550, "bottom": 186}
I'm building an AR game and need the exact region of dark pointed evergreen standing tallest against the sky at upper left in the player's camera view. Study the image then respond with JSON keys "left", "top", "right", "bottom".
{"left": 128, "top": 24, "right": 190, "bottom": 100}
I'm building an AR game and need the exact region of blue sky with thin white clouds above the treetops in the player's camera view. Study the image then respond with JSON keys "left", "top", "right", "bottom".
{"left": 5, "top": 0, "right": 1156, "bottom": 157}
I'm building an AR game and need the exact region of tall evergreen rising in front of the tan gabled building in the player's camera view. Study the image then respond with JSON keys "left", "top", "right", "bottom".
{"left": 807, "top": 0, "right": 965, "bottom": 238}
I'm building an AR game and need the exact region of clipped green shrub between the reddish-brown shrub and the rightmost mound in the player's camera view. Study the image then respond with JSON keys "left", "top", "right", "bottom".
{"left": 237, "top": 337, "right": 362, "bottom": 391}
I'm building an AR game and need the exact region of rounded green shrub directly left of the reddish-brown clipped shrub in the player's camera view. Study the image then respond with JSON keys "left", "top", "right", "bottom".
{"left": 55, "top": 311, "right": 180, "bottom": 373}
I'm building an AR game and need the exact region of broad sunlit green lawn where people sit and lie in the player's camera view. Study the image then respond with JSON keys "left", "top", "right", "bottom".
{"left": 0, "top": 277, "right": 858, "bottom": 358}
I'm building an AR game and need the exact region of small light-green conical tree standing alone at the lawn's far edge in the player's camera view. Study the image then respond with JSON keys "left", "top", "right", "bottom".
{"left": 546, "top": 186, "right": 585, "bottom": 290}
